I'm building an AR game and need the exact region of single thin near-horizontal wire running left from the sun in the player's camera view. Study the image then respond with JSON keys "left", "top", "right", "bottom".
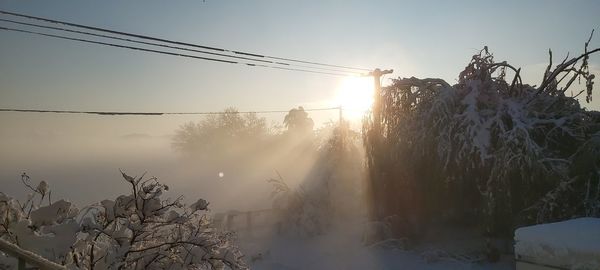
{"left": 0, "top": 107, "right": 341, "bottom": 116}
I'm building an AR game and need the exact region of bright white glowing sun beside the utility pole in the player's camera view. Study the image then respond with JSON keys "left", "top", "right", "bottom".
{"left": 334, "top": 77, "right": 374, "bottom": 120}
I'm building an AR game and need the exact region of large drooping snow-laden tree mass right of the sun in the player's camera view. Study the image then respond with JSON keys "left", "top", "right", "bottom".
{"left": 364, "top": 41, "right": 600, "bottom": 235}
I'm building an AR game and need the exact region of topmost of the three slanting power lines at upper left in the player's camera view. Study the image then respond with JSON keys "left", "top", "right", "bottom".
{"left": 0, "top": 10, "right": 371, "bottom": 71}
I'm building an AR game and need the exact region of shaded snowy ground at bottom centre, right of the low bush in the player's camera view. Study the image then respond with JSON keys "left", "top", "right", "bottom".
{"left": 240, "top": 224, "right": 514, "bottom": 270}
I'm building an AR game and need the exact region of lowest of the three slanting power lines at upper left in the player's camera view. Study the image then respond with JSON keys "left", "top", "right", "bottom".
{"left": 0, "top": 26, "right": 356, "bottom": 76}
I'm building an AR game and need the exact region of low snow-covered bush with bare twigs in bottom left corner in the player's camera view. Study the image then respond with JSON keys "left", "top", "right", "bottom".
{"left": 0, "top": 173, "right": 247, "bottom": 269}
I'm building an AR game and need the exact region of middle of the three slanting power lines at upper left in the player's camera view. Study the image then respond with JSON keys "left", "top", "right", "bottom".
{"left": 0, "top": 19, "right": 361, "bottom": 75}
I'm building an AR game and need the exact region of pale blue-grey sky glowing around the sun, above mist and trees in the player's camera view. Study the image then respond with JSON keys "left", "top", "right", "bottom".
{"left": 0, "top": 0, "right": 600, "bottom": 207}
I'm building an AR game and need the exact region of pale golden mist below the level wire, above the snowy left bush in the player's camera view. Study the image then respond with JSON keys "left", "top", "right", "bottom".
{"left": 0, "top": 110, "right": 342, "bottom": 212}
